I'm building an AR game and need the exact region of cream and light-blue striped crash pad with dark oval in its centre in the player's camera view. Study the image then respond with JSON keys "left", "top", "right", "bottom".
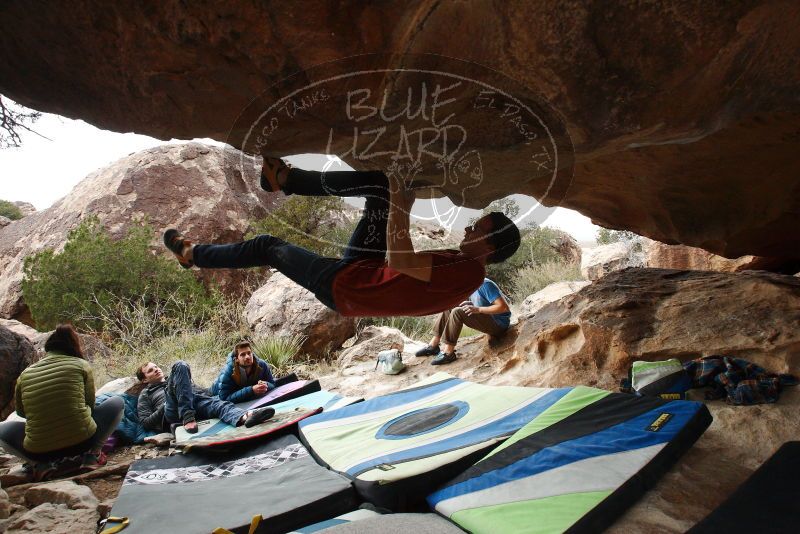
{"left": 299, "top": 373, "right": 551, "bottom": 511}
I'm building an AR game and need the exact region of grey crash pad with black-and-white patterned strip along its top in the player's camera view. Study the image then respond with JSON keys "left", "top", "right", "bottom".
{"left": 107, "top": 435, "right": 358, "bottom": 534}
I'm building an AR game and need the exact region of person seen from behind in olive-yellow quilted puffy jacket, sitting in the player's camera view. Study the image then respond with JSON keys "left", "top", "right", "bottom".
{"left": 0, "top": 325, "right": 124, "bottom": 480}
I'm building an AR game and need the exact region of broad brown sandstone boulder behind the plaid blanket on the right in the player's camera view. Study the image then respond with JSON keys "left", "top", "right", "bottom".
{"left": 506, "top": 269, "right": 800, "bottom": 388}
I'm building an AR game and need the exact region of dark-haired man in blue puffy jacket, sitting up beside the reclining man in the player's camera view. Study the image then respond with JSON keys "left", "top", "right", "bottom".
{"left": 211, "top": 341, "right": 275, "bottom": 403}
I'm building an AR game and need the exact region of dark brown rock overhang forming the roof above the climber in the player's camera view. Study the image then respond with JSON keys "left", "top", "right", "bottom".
{"left": 0, "top": 0, "right": 800, "bottom": 257}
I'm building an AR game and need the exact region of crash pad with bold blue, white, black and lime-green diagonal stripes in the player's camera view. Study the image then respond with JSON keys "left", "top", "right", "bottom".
{"left": 428, "top": 387, "right": 711, "bottom": 533}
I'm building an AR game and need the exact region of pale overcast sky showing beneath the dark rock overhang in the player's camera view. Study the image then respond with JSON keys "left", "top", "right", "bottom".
{"left": 0, "top": 109, "right": 598, "bottom": 243}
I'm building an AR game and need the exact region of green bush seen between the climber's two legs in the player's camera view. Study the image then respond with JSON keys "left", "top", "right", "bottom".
{"left": 247, "top": 196, "right": 355, "bottom": 256}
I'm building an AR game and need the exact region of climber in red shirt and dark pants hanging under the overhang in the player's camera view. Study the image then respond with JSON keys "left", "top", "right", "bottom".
{"left": 164, "top": 158, "right": 520, "bottom": 317}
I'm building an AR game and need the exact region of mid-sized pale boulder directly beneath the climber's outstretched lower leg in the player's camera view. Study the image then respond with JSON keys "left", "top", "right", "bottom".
{"left": 244, "top": 273, "right": 355, "bottom": 356}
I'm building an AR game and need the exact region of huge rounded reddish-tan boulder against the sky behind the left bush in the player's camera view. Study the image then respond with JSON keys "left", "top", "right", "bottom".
{"left": 0, "top": 143, "right": 277, "bottom": 324}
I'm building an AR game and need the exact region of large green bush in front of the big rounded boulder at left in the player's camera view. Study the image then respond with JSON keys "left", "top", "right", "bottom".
{"left": 22, "top": 218, "right": 219, "bottom": 335}
